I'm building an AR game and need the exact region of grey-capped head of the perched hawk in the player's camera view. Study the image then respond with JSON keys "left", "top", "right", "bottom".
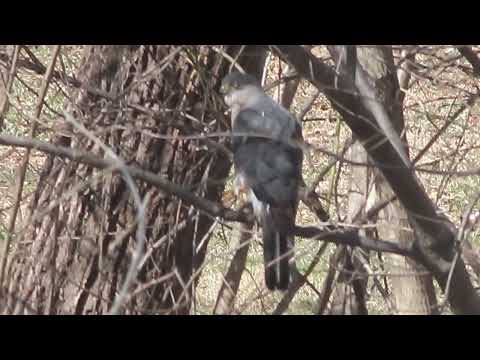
{"left": 220, "top": 71, "right": 263, "bottom": 106}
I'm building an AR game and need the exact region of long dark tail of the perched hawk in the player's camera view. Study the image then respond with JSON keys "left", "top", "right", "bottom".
{"left": 262, "top": 207, "right": 295, "bottom": 290}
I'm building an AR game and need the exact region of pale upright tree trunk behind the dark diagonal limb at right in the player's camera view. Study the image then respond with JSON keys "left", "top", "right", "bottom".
{"left": 358, "top": 46, "right": 436, "bottom": 314}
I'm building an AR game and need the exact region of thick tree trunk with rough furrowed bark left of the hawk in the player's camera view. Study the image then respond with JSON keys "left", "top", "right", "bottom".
{"left": 2, "top": 45, "right": 264, "bottom": 314}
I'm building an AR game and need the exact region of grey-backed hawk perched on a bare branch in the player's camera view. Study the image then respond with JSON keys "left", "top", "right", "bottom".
{"left": 220, "top": 72, "right": 303, "bottom": 290}
